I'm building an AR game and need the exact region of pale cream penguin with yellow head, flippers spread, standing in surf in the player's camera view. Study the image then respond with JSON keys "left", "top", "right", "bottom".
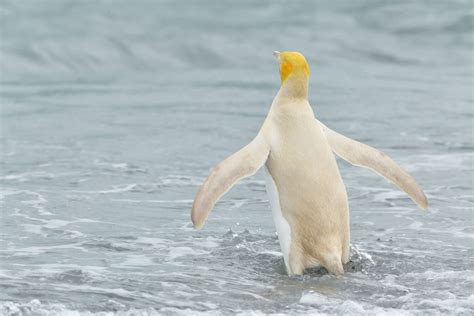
{"left": 191, "top": 51, "right": 428, "bottom": 275}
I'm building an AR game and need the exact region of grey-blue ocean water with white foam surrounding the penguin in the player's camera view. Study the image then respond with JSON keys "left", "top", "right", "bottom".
{"left": 0, "top": 0, "right": 474, "bottom": 315}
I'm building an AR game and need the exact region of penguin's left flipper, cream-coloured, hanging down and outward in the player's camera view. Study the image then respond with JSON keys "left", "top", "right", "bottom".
{"left": 191, "top": 134, "right": 270, "bottom": 228}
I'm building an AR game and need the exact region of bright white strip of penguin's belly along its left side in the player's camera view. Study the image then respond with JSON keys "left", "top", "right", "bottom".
{"left": 265, "top": 167, "right": 291, "bottom": 270}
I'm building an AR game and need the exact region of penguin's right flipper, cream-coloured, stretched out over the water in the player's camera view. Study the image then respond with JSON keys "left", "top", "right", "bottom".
{"left": 318, "top": 121, "right": 428, "bottom": 209}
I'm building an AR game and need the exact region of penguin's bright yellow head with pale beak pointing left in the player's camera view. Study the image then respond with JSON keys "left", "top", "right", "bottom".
{"left": 273, "top": 51, "right": 309, "bottom": 84}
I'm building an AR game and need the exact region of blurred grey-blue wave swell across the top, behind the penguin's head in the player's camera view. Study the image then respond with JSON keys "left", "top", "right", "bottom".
{"left": 0, "top": 1, "right": 472, "bottom": 82}
